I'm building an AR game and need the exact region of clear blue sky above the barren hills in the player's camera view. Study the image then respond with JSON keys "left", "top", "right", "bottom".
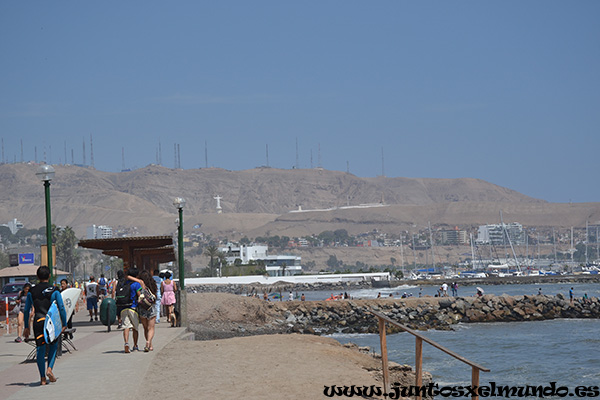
{"left": 0, "top": 0, "right": 600, "bottom": 202}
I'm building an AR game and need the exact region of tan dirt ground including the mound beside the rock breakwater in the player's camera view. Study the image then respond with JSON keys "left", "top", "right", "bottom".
{"left": 139, "top": 293, "right": 426, "bottom": 400}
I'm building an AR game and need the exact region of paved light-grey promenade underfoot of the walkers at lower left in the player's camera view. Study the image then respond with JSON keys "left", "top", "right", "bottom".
{"left": 0, "top": 306, "right": 186, "bottom": 400}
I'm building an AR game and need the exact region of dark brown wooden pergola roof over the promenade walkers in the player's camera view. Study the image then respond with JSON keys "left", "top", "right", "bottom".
{"left": 79, "top": 236, "right": 176, "bottom": 271}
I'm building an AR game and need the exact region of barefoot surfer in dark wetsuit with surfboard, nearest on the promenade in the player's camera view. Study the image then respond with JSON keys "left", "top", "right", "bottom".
{"left": 23, "top": 266, "right": 67, "bottom": 385}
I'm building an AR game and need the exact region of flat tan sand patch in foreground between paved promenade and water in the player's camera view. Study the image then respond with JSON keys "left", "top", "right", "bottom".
{"left": 138, "top": 334, "right": 381, "bottom": 400}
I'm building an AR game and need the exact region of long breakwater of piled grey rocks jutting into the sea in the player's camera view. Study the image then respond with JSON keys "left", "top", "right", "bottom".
{"left": 269, "top": 294, "right": 600, "bottom": 334}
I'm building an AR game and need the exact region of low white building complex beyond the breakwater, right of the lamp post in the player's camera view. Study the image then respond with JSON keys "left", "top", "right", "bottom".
{"left": 219, "top": 244, "right": 302, "bottom": 276}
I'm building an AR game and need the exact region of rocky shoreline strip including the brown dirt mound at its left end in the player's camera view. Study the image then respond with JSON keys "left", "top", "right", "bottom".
{"left": 188, "top": 293, "right": 600, "bottom": 340}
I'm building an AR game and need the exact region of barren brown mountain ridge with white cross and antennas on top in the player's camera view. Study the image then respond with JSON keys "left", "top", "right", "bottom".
{"left": 0, "top": 164, "right": 600, "bottom": 237}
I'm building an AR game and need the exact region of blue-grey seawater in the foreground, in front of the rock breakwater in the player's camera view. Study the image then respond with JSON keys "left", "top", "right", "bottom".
{"left": 331, "top": 319, "right": 600, "bottom": 398}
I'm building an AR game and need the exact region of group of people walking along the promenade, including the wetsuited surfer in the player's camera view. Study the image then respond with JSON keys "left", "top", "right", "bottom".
{"left": 15, "top": 266, "right": 177, "bottom": 385}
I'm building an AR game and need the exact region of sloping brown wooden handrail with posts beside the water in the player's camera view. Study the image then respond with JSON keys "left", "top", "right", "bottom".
{"left": 369, "top": 310, "right": 490, "bottom": 400}
